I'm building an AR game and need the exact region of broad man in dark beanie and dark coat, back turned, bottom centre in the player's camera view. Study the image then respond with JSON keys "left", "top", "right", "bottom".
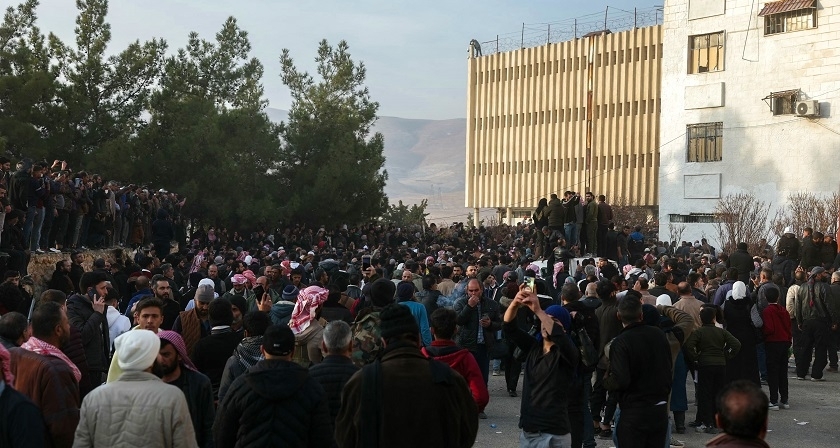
{"left": 335, "top": 302, "right": 478, "bottom": 447}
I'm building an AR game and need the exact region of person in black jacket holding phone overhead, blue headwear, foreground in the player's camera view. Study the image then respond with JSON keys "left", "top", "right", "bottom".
{"left": 502, "top": 284, "right": 579, "bottom": 448}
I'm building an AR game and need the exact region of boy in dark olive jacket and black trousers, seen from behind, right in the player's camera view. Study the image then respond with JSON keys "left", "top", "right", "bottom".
{"left": 683, "top": 306, "right": 741, "bottom": 434}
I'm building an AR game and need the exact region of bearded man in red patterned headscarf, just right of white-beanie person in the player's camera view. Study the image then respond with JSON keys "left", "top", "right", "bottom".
{"left": 153, "top": 330, "right": 216, "bottom": 448}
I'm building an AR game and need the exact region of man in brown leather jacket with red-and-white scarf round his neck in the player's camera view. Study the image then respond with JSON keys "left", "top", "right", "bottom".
{"left": 9, "top": 302, "right": 82, "bottom": 448}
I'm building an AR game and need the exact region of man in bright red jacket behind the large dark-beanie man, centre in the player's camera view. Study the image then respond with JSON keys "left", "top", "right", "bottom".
{"left": 423, "top": 308, "right": 490, "bottom": 418}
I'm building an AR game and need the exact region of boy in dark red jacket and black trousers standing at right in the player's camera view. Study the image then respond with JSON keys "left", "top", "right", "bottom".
{"left": 761, "top": 288, "right": 791, "bottom": 411}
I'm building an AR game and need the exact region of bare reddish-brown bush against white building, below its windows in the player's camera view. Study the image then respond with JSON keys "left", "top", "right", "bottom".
{"left": 715, "top": 193, "right": 770, "bottom": 253}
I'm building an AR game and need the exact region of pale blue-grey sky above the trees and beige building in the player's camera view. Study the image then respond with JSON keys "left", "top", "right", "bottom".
{"left": 34, "top": 0, "right": 661, "bottom": 119}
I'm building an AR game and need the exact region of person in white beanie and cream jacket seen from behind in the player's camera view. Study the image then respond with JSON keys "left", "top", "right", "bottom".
{"left": 73, "top": 329, "right": 198, "bottom": 447}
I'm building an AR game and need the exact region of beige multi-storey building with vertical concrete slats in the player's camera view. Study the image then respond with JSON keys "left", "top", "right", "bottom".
{"left": 465, "top": 20, "right": 663, "bottom": 223}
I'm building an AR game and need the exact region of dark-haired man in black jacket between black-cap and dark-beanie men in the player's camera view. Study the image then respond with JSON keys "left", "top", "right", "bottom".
{"left": 309, "top": 320, "right": 359, "bottom": 422}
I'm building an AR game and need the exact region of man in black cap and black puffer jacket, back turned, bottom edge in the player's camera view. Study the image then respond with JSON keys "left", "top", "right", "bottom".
{"left": 213, "top": 325, "right": 335, "bottom": 447}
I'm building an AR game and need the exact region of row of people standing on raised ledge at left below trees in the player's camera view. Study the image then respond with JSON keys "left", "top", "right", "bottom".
{"left": 0, "top": 157, "right": 186, "bottom": 275}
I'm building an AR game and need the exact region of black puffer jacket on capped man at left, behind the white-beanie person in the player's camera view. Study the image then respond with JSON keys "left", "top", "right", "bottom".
{"left": 67, "top": 294, "right": 111, "bottom": 374}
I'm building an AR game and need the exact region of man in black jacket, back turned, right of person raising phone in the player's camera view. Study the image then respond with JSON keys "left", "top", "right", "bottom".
{"left": 604, "top": 295, "right": 672, "bottom": 448}
